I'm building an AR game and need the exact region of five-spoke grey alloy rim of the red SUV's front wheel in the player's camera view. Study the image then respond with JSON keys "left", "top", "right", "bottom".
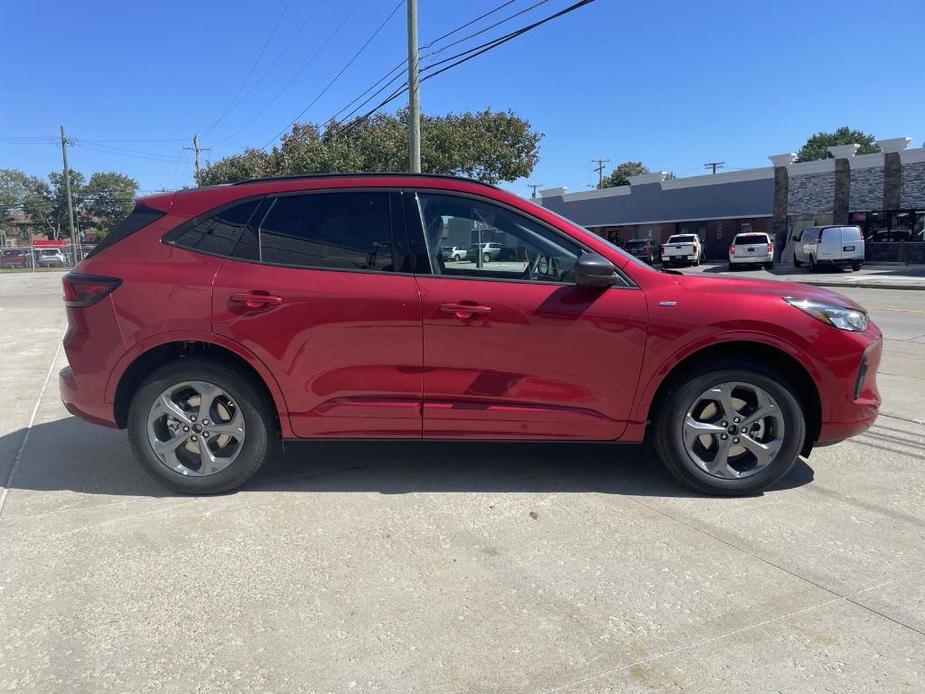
{"left": 682, "top": 382, "right": 785, "bottom": 479}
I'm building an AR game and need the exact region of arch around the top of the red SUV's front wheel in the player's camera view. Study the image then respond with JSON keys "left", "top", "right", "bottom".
{"left": 645, "top": 340, "right": 823, "bottom": 455}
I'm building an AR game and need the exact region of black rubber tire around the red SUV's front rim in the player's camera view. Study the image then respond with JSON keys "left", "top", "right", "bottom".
{"left": 653, "top": 360, "right": 806, "bottom": 496}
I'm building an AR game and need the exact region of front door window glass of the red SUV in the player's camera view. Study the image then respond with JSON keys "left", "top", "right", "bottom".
{"left": 418, "top": 193, "right": 581, "bottom": 283}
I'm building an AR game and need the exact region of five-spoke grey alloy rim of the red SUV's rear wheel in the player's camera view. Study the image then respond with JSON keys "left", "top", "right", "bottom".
{"left": 147, "top": 381, "right": 245, "bottom": 477}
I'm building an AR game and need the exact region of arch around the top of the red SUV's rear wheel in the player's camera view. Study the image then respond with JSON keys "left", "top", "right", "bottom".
{"left": 110, "top": 339, "right": 292, "bottom": 438}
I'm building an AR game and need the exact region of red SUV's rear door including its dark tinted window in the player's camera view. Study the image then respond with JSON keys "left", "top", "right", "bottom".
{"left": 213, "top": 190, "right": 422, "bottom": 438}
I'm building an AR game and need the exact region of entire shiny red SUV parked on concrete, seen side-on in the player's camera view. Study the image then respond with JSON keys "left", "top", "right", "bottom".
{"left": 61, "top": 174, "right": 881, "bottom": 495}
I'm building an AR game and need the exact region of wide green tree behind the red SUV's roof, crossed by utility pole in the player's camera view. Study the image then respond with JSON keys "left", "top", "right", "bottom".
{"left": 197, "top": 110, "right": 543, "bottom": 185}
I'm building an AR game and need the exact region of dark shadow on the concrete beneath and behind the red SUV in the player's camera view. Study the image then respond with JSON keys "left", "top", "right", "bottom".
{"left": 0, "top": 417, "right": 813, "bottom": 497}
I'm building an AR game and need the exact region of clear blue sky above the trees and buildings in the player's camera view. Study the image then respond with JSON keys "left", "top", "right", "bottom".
{"left": 0, "top": 0, "right": 925, "bottom": 194}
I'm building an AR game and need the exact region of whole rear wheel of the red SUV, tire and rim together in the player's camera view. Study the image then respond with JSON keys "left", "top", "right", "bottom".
{"left": 128, "top": 359, "right": 274, "bottom": 494}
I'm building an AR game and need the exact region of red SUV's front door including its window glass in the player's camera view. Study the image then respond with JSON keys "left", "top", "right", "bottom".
{"left": 406, "top": 190, "right": 647, "bottom": 440}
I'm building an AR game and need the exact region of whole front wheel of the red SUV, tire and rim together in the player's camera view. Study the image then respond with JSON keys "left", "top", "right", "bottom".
{"left": 654, "top": 362, "right": 806, "bottom": 496}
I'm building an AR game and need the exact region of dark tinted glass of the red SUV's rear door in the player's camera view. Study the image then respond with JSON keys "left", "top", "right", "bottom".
{"left": 260, "top": 192, "right": 394, "bottom": 271}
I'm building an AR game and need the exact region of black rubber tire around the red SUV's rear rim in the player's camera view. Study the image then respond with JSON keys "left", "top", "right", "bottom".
{"left": 127, "top": 358, "right": 276, "bottom": 494}
